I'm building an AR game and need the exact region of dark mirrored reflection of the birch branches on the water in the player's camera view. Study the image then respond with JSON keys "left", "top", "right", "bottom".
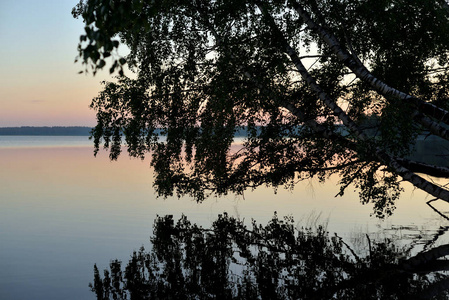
{"left": 90, "top": 213, "right": 449, "bottom": 299}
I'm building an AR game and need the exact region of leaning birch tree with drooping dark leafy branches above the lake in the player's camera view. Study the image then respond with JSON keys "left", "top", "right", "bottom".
{"left": 73, "top": 0, "right": 449, "bottom": 217}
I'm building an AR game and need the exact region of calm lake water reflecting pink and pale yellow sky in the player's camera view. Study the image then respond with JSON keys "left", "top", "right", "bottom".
{"left": 0, "top": 136, "right": 449, "bottom": 299}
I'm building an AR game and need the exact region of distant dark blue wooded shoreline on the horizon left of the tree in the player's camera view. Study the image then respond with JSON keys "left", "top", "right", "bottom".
{"left": 0, "top": 126, "right": 92, "bottom": 136}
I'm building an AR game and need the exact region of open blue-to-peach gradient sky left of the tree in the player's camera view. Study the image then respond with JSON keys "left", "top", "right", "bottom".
{"left": 0, "top": 0, "right": 122, "bottom": 127}
